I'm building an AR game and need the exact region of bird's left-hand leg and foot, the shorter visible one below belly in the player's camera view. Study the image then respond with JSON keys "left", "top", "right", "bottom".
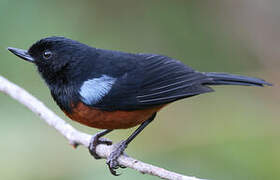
{"left": 88, "top": 129, "right": 112, "bottom": 159}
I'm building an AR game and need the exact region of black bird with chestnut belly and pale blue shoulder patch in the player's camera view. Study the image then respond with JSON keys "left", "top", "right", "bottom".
{"left": 8, "top": 36, "right": 272, "bottom": 175}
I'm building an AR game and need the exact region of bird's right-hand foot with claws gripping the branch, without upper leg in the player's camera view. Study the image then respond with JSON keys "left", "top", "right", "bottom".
{"left": 106, "top": 141, "right": 127, "bottom": 176}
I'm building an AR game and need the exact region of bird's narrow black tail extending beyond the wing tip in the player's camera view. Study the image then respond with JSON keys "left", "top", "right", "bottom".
{"left": 204, "top": 72, "right": 272, "bottom": 86}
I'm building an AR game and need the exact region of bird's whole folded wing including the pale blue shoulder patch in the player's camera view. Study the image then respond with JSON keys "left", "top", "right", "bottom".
{"left": 76, "top": 51, "right": 212, "bottom": 110}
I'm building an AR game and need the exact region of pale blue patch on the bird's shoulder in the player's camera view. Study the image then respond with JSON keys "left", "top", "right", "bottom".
{"left": 79, "top": 75, "right": 116, "bottom": 104}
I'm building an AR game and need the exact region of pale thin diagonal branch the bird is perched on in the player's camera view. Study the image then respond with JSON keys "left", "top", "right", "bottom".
{"left": 0, "top": 76, "right": 206, "bottom": 180}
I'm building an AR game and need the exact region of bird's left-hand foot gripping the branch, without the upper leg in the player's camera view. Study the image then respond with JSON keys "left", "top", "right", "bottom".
{"left": 88, "top": 133, "right": 112, "bottom": 159}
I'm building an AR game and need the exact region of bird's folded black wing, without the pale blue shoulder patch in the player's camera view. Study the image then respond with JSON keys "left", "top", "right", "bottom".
{"left": 93, "top": 54, "right": 213, "bottom": 110}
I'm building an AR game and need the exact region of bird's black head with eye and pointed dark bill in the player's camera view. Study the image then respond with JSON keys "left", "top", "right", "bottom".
{"left": 8, "top": 36, "right": 96, "bottom": 84}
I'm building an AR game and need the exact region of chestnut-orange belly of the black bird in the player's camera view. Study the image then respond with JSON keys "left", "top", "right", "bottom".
{"left": 65, "top": 103, "right": 163, "bottom": 129}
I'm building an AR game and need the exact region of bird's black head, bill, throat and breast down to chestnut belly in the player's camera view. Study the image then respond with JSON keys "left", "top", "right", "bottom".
{"left": 8, "top": 37, "right": 100, "bottom": 112}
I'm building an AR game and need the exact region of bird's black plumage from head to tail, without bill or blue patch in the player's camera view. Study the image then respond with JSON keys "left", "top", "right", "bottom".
{"left": 8, "top": 37, "right": 270, "bottom": 112}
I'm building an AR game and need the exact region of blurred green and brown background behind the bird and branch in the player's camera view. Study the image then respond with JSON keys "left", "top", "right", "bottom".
{"left": 0, "top": 0, "right": 280, "bottom": 180}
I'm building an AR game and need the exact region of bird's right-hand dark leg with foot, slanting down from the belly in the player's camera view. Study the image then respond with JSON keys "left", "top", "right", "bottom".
{"left": 106, "top": 113, "right": 156, "bottom": 176}
